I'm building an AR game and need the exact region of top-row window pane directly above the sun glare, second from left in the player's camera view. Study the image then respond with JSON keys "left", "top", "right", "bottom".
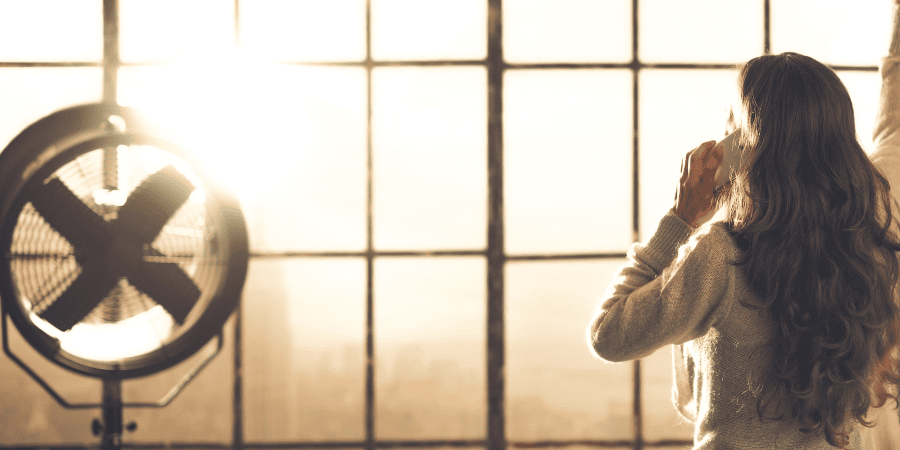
{"left": 119, "top": 0, "right": 234, "bottom": 62}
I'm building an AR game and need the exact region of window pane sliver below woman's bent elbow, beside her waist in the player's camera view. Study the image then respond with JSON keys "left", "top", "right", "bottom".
{"left": 641, "top": 345, "right": 694, "bottom": 441}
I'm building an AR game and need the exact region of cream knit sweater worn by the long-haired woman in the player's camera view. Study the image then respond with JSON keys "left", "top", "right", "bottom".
{"left": 588, "top": 7, "right": 900, "bottom": 450}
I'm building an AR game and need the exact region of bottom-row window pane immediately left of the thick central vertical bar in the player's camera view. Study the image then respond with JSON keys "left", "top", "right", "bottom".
{"left": 375, "top": 258, "right": 487, "bottom": 439}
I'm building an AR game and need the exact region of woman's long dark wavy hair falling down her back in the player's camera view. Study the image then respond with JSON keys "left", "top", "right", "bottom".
{"left": 724, "top": 53, "right": 900, "bottom": 447}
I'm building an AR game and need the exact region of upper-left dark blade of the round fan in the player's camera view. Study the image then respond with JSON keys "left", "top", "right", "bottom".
{"left": 30, "top": 178, "right": 112, "bottom": 249}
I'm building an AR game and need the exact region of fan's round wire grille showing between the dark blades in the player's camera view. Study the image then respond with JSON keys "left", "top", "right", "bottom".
{"left": 8, "top": 146, "right": 227, "bottom": 356}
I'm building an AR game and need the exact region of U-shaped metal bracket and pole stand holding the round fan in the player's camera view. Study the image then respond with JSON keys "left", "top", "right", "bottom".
{"left": 0, "top": 308, "right": 224, "bottom": 450}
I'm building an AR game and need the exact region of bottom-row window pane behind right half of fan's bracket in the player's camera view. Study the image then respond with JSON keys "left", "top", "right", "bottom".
{"left": 123, "top": 317, "right": 236, "bottom": 443}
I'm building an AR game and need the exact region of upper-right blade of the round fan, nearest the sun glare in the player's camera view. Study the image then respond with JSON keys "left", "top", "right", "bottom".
{"left": 115, "top": 164, "right": 195, "bottom": 244}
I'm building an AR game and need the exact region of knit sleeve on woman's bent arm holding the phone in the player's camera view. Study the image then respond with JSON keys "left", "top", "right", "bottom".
{"left": 588, "top": 211, "right": 733, "bottom": 361}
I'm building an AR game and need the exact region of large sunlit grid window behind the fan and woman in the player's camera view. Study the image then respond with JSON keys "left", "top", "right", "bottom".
{"left": 0, "top": 0, "right": 891, "bottom": 449}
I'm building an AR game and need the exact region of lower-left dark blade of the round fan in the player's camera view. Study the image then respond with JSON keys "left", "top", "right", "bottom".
{"left": 38, "top": 269, "right": 117, "bottom": 331}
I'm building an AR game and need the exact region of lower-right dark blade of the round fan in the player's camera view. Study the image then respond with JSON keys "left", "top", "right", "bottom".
{"left": 128, "top": 261, "right": 200, "bottom": 324}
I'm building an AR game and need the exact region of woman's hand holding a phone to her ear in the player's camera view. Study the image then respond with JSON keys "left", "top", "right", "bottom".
{"left": 672, "top": 142, "right": 724, "bottom": 228}
